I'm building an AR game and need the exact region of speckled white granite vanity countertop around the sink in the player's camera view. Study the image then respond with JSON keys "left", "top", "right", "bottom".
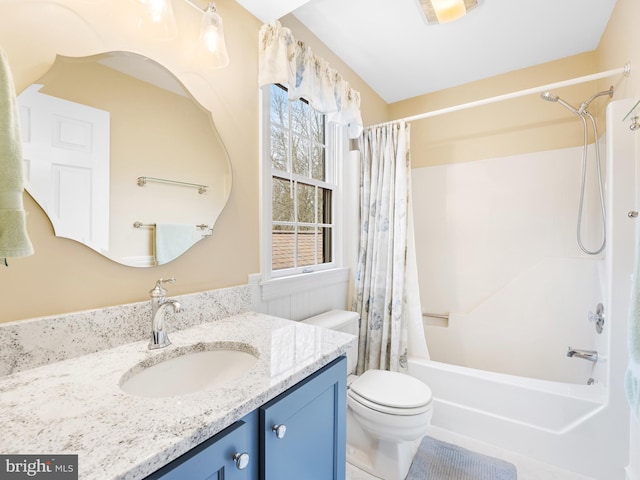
{"left": 0, "top": 312, "right": 356, "bottom": 480}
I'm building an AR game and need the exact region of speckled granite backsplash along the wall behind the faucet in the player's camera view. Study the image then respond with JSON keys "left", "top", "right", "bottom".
{"left": 0, "top": 285, "right": 251, "bottom": 377}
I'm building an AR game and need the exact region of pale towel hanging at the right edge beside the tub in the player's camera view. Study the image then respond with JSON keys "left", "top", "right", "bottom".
{"left": 624, "top": 237, "right": 640, "bottom": 421}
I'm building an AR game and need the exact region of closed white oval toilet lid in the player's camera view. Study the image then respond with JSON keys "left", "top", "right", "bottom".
{"left": 350, "top": 370, "right": 433, "bottom": 409}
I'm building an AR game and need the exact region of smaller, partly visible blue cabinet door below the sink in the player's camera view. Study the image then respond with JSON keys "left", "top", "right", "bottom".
{"left": 146, "top": 412, "right": 259, "bottom": 480}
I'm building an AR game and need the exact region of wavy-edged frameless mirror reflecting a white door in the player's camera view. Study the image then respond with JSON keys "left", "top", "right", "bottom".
{"left": 18, "top": 52, "right": 231, "bottom": 267}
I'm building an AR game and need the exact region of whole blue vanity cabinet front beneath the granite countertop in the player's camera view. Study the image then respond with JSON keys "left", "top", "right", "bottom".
{"left": 145, "top": 357, "right": 347, "bottom": 480}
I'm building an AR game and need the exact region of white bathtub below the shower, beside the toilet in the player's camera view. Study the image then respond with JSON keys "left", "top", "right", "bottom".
{"left": 408, "top": 358, "right": 628, "bottom": 480}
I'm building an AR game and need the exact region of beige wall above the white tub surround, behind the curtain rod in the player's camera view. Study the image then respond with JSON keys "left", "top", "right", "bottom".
{"left": 390, "top": 52, "right": 598, "bottom": 168}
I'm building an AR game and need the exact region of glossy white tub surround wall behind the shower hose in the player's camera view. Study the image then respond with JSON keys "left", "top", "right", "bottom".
{"left": 412, "top": 144, "right": 606, "bottom": 384}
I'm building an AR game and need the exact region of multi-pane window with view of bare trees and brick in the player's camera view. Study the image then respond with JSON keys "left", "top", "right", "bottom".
{"left": 263, "top": 85, "right": 337, "bottom": 277}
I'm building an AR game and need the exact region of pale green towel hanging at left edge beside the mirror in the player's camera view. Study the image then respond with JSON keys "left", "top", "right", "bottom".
{"left": 0, "top": 48, "right": 33, "bottom": 259}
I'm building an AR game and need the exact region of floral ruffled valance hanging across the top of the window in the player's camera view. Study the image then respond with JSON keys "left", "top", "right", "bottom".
{"left": 258, "top": 21, "right": 363, "bottom": 138}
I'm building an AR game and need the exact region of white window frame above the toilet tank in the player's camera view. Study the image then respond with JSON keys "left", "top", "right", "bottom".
{"left": 260, "top": 84, "right": 346, "bottom": 282}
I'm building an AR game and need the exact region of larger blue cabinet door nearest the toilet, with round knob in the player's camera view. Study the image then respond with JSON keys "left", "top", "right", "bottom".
{"left": 260, "top": 357, "right": 347, "bottom": 480}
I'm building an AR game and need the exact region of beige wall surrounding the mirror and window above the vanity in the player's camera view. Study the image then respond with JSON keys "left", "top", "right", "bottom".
{"left": 0, "top": 0, "right": 387, "bottom": 321}
